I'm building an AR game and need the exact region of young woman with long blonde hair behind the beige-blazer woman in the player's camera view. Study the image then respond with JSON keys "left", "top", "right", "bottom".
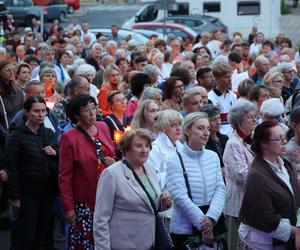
{"left": 131, "top": 100, "right": 159, "bottom": 140}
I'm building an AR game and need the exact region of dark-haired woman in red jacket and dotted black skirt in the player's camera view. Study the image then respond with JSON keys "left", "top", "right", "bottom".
{"left": 59, "top": 95, "right": 115, "bottom": 250}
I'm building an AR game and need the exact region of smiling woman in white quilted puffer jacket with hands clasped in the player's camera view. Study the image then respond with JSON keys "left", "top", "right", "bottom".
{"left": 167, "top": 112, "right": 225, "bottom": 250}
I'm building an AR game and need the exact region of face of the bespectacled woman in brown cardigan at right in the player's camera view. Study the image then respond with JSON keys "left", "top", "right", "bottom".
{"left": 262, "top": 125, "right": 287, "bottom": 157}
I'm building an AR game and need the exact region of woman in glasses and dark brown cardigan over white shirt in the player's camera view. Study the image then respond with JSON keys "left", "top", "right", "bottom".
{"left": 239, "top": 121, "right": 300, "bottom": 250}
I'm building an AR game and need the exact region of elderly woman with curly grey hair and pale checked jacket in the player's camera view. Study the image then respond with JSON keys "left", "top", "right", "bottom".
{"left": 223, "top": 100, "right": 257, "bottom": 249}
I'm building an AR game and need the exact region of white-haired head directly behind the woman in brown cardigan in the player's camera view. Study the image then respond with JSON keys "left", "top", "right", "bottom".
{"left": 260, "top": 98, "right": 289, "bottom": 132}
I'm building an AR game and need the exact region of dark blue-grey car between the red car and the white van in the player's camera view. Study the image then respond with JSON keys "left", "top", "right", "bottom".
{"left": 159, "top": 15, "right": 227, "bottom": 33}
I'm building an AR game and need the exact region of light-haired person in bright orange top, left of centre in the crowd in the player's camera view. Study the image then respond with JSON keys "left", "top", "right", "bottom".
{"left": 98, "top": 64, "right": 121, "bottom": 117}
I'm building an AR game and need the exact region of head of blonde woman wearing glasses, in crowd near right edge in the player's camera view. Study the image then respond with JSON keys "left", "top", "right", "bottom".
{"left": 263, "top": 71, "right": 284, "bottom": 99}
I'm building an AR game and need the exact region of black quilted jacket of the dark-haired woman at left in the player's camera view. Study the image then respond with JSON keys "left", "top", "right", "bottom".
{"left": 4, "top": 123, "right": 58, "bottom": 199}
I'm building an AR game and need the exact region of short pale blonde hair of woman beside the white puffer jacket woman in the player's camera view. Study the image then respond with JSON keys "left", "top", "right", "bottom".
{"left": 154, "top": 109, "right": 183, "bottom": 131}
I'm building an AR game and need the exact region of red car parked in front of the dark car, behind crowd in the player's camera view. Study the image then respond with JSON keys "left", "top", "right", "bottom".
{"left": 132, "top": 22, "right": 197, "bottom": 40}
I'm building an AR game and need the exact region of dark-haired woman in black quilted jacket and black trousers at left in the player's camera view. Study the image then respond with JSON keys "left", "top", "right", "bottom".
{"left": 4, "top": 96, "right": 58, "bottom": 250}
